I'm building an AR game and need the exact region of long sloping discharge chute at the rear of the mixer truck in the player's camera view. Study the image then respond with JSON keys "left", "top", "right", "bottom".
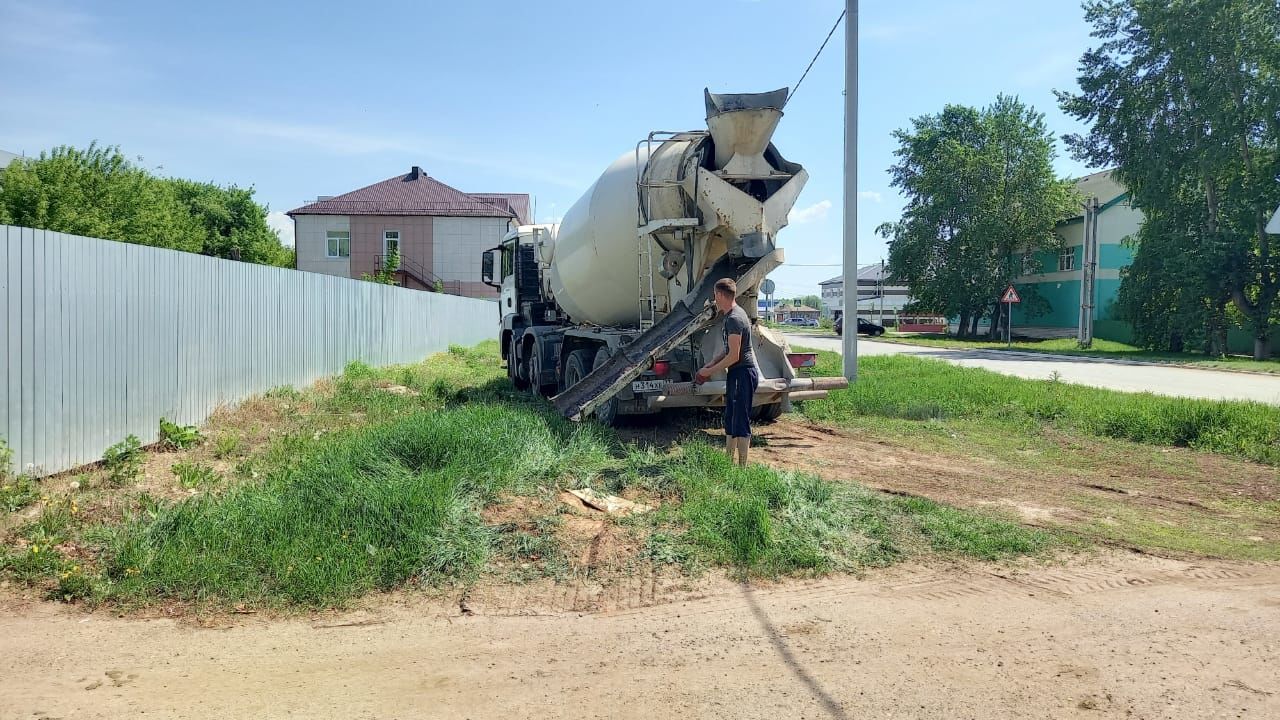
{"left": 552, "top": 250, "right": 778, "bottom": 421}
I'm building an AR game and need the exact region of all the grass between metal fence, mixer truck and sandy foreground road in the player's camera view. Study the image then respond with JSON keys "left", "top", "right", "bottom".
{"left": 0, "top": 343, "right": 1060, "bottom": 607}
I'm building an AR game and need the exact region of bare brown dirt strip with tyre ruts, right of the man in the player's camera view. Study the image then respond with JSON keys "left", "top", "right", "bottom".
{"left": 751, "top": 416, "right": 1280, "bottom": 560}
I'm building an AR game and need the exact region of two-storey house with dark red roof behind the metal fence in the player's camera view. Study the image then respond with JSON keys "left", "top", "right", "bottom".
{"left": 288, "top": 165, "right": 531, "bottom": 297}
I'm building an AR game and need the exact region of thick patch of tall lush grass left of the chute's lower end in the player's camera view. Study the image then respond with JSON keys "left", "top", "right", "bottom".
{"left": 106, "top": 404, "right": 609, "bottom": 607}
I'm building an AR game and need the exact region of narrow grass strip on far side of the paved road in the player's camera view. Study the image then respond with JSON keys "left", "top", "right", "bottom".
{"left": 877, "top": 334, "right": 1280, "bottom": 373}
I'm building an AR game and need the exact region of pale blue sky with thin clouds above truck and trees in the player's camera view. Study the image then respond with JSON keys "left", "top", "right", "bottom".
{"left": 0, "top": 0, "right": 1097, "bottom": 297}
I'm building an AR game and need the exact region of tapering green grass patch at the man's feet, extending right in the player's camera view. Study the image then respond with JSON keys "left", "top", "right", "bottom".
{"left": 645, "top": 441, "right": 1057, "bottom": 577}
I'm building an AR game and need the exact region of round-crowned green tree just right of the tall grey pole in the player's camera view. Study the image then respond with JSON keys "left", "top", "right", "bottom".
{"left": 878, "top": 95, "right": 1075, "bottom": 334}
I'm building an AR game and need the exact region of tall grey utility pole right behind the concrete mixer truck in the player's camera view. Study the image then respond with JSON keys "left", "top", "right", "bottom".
{"left": 841, "top": 0, "right": 858, "bottom": 382}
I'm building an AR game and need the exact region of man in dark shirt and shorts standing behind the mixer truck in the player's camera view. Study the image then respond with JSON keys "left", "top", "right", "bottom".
{"left": 694, "top": 278, "right": 760, "bottom": 465}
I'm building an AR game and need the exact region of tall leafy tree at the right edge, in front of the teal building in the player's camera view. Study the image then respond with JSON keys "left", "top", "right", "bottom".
{"left": 1059, "top": 0, "right": 1280, "bottom": 359}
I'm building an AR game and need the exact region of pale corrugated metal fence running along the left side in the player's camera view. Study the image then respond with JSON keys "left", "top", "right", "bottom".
{"left": 0, "top": 225, "right": 498, "bottom": 473}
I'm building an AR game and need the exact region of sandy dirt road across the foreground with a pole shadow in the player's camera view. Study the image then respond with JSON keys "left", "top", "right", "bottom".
{"left": 0, "top": 553, "right": 1280, "bottom": 720}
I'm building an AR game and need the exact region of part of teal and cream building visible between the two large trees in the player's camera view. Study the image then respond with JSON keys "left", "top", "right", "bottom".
{"left": 1012, "top": 170, "right": 1143, "bottom": 341}
